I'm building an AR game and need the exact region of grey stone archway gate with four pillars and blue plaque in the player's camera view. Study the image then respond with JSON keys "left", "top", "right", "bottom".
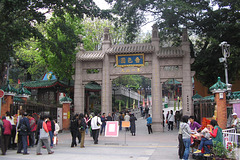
{"left": 74, "top": 26, "right": 194, "bottom": 131}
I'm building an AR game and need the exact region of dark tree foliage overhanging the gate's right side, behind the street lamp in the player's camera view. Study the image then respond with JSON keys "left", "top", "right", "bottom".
{"left": 106, "top": 0, "right": 240, "bottom": 86}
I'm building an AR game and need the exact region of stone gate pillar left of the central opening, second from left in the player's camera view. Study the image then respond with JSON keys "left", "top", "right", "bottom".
{"left": 101, "top": 28, "right": 112, "bottom": 114}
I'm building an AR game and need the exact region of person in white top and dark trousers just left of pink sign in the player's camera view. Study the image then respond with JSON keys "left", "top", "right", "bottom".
{"left": 91, "top": 113, "right": 102, "bottom": 144}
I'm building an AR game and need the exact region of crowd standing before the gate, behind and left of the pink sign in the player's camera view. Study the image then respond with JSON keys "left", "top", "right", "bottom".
{"left": 70, "top": 111, "right": 137, "bottom": 148}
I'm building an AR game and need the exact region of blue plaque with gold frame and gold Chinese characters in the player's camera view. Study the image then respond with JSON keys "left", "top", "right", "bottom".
{"left": 116, "top": 53, "right": 144, "bottom": 67}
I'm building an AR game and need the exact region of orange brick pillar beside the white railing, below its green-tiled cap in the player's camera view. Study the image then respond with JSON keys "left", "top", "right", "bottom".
{"left": 215, "top": 91, "right": 227, "bottom": 129}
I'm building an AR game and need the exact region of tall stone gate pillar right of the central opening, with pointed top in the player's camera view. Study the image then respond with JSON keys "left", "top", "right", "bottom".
{"left": 151, "top": 25, "right": 163, "bottom": 132}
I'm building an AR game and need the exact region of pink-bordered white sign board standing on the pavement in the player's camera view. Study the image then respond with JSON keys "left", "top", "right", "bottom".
{"left": 105, "top": 121, "right": 118, "bottom": 137}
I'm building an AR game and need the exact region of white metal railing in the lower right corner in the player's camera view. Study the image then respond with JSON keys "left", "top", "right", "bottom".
{"left": 222, "top": 128, "right": 240, "bottom": 159}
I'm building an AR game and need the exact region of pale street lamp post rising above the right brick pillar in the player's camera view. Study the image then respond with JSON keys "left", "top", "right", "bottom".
{"left": 219, "top": 41, "right": 230, "bottom": 88}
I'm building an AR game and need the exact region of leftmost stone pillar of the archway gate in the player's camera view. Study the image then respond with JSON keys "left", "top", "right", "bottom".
{"left": 74, "top": 38, "right": 85, "bottom": 113}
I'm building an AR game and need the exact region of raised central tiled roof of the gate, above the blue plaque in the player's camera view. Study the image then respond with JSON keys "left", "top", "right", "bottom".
{"left": 106, "top": 43, "right": 154, "bottom": 54}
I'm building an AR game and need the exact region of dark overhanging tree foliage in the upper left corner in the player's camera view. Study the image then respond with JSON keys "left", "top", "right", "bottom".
{"left": 0, "top": 0, "right": 109, "bottom": 83}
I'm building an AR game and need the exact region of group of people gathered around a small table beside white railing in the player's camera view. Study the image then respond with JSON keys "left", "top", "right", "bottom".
{"left": 178, "top": 115, "right": 226, "bottom": 160}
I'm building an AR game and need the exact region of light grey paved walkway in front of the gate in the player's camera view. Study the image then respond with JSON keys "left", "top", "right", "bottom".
{"left": 0, "top": 118, "right": 182, "bottom": 160}
